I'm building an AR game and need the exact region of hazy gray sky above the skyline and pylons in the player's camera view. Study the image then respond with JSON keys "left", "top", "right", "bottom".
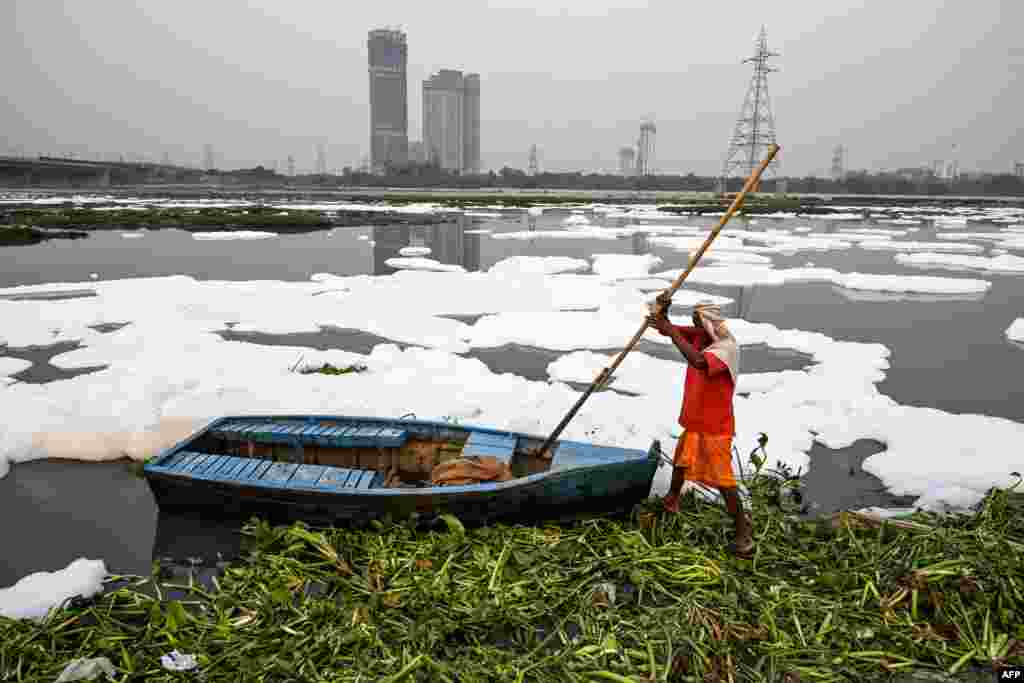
{"left": 0, "top": 0, "right": 1024, "bottom": 175}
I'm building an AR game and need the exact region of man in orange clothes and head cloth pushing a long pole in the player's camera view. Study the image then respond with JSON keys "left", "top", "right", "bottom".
{"left": 647, "top": 296, "right": 754, "bottom": 557}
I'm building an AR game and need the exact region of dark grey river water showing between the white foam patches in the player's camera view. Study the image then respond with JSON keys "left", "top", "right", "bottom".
{"left": 0, "top": 200, "right": 1024, "bottom": 587}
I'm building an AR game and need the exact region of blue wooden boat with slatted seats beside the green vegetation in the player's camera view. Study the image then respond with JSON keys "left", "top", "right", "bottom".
{"left": 143, "top": 416, "right": 660, "bottom": 523}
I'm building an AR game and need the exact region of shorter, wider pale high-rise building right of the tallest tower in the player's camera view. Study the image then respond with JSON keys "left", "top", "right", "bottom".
{"left": 423, "top": 69, "right": 480, "bottom": 173}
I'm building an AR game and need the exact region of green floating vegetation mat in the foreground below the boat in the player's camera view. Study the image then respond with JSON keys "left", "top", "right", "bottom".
{"left": 0, "top": 483, "right": 1024, "bottom": 683}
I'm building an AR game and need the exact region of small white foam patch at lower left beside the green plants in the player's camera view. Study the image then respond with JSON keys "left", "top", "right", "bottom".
{"left": 0, "top": 557, "right": 106, "bottom": 621}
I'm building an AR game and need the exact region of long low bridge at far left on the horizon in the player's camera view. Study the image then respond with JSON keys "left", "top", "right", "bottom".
{"left": 0, "top": 156, "right": 204, "bottom": 187}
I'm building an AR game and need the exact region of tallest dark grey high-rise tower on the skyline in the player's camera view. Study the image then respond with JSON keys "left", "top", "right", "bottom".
{"left": 367, "top": 29, "right": 409, "bottom": 173}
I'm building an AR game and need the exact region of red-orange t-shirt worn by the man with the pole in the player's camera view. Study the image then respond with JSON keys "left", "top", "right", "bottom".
{"left": 673, "top": 325, "right": 736, "bottom": 436}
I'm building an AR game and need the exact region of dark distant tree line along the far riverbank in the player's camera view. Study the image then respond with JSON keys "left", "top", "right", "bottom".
{"left": 221, "top": 163, "right": 1024, "bottom": 197}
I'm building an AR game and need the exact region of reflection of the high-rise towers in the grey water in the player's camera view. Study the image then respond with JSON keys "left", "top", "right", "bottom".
{"left": 373, "top": 215, "right": 481, "bottom": 275}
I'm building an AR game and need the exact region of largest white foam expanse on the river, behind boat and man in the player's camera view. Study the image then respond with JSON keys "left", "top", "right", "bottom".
{"left": 0, "top": 268, "right": 1024, "bottom": 511}
